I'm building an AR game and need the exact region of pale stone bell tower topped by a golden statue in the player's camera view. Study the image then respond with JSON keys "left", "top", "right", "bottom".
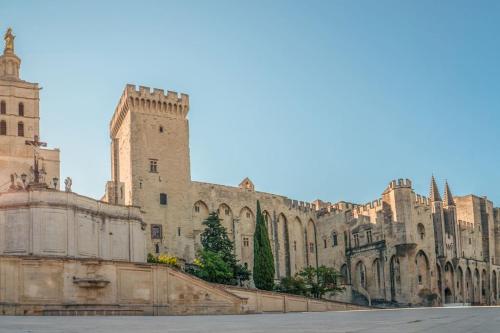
{"left": 0, "top": 28, "right": 59, "bottom": 192}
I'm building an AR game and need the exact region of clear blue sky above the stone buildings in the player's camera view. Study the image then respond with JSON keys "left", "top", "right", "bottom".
{"left": 0, "top": 0, "right": 500, "bottom": 205}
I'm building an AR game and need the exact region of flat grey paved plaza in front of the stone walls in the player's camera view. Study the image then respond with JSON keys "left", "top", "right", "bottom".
{"left": 0, "top": 307, "right": 500, "bottom": 333}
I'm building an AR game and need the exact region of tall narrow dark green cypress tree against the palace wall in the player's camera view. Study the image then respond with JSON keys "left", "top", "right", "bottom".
{"left": 253, "top": 200, "right": 274, "bottom": 290}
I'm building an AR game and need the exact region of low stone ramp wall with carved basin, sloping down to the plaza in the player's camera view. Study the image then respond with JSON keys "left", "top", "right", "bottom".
{"left": 0, "top": 256, "right": 370, "bottom": 315}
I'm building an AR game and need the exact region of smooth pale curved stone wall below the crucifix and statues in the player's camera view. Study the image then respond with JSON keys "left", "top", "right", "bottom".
{"left": 0, "top": 190, "right": 146, "bottom": 262}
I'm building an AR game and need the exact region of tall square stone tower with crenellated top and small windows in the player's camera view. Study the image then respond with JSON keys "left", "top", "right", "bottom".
{"left": 106, "top": 84, "right": 194, "bottom": 259}
